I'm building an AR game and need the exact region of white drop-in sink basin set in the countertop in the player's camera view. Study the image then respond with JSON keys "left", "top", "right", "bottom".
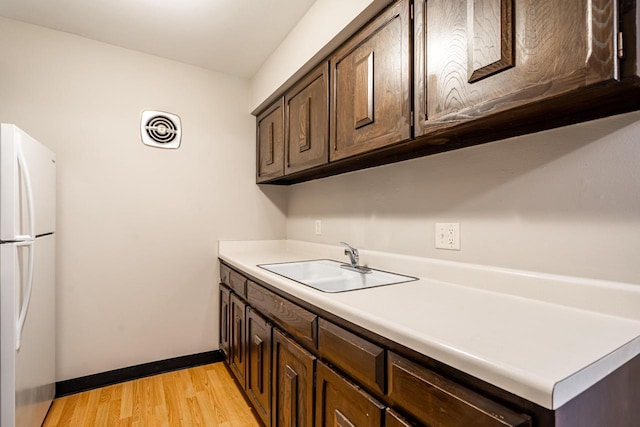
{"left": 258, "top": 259, "right": 418, "bottom": 292}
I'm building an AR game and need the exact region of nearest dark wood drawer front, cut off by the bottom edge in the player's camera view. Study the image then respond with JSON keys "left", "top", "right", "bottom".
{"left": 388, "top": 352, "right": 531, "bottom": 427}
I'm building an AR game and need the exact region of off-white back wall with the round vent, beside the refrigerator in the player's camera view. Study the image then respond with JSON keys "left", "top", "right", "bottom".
{"left": 0, "top": 18, "right": 286, "bottom": 380}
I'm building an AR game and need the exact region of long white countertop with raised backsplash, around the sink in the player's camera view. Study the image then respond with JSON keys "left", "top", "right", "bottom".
{"left": 218, "top": 240, "right": 640, "bottom": 409}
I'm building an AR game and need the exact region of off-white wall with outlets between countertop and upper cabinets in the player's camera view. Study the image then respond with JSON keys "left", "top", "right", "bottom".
{"left": 287, "top": 112, "right": 640, "bottom": 284}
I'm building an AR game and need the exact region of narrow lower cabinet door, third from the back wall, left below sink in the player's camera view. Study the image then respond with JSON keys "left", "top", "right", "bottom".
{"left": 245, "top": 307, "right": 272, "bottom": 426}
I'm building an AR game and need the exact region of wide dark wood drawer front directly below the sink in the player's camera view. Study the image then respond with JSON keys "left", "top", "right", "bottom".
{"left": 247, "top": 281, "right": 318, "bottom": 349}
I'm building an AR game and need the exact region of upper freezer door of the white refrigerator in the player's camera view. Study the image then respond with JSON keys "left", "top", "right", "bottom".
{"left": 0, "top": 123, "right": 56, "bottom": 242}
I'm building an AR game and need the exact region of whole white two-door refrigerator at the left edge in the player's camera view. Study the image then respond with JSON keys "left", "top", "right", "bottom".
{"left": 0, "top": 124, "right": 56, "bottom": 427}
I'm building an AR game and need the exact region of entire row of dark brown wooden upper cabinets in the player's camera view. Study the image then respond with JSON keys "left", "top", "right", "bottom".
{"left": 257, "top": 0, "right": 640, "bottom": 185}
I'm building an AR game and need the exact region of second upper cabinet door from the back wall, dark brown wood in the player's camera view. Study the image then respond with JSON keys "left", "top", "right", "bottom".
{"left": 284, "top": 62, "right": 329, "bottom": 174}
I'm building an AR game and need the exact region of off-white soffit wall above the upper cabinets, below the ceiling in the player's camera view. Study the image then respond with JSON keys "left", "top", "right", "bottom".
{"left": 251, "top": 0, "right": 391, "bottom": 111}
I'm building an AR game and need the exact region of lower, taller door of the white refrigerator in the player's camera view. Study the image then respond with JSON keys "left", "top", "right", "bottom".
{"left": 0, "top": 235, "right": 55, "bottom": 427}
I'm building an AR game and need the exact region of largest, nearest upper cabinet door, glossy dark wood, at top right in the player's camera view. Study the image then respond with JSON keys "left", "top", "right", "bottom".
{"left": 414, "top": 0, "right": 618, "bottom": 136}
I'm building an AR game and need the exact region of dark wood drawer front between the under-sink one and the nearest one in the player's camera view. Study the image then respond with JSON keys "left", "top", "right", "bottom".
{"left": 318, "top": 319, "right": 385, "bottom": 394}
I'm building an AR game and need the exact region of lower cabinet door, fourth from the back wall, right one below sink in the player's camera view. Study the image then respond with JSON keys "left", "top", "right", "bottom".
{"left": 271, "top": 329, "right": 316, "bottom": 427}
